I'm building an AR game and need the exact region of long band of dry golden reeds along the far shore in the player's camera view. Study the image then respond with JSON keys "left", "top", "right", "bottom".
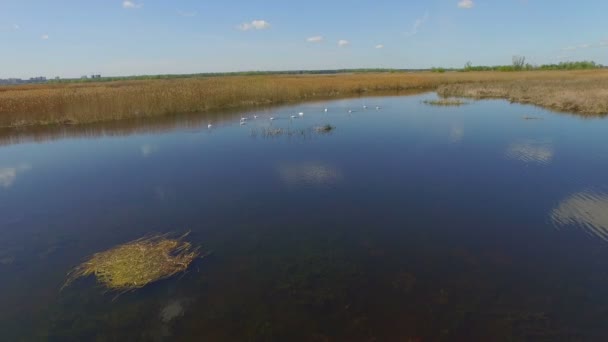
{"left": 0, "top": 70, "right": 608, "bottom": 127}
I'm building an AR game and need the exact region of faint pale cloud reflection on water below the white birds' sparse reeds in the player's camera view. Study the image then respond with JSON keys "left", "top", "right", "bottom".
{"left": 278, "top": 161, "right": 343, "bottom": 185}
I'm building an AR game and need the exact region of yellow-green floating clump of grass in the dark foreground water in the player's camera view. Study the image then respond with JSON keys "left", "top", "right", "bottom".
{"left": 63, "top": 234, "right": 199, "bottom": 292}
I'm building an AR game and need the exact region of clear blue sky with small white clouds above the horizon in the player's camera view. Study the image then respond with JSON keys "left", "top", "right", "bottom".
{"left": 0, "top": 0, "right": 608, "bottom": 78}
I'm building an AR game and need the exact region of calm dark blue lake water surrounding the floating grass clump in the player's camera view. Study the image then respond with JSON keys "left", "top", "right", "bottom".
{"left": 0, "top": 94, "right": 608, "bottom": 341}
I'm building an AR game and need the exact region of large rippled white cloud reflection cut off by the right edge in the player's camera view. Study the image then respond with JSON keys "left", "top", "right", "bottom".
{"left": 551, "top": 191, "right": 608, "bottom": 241}
